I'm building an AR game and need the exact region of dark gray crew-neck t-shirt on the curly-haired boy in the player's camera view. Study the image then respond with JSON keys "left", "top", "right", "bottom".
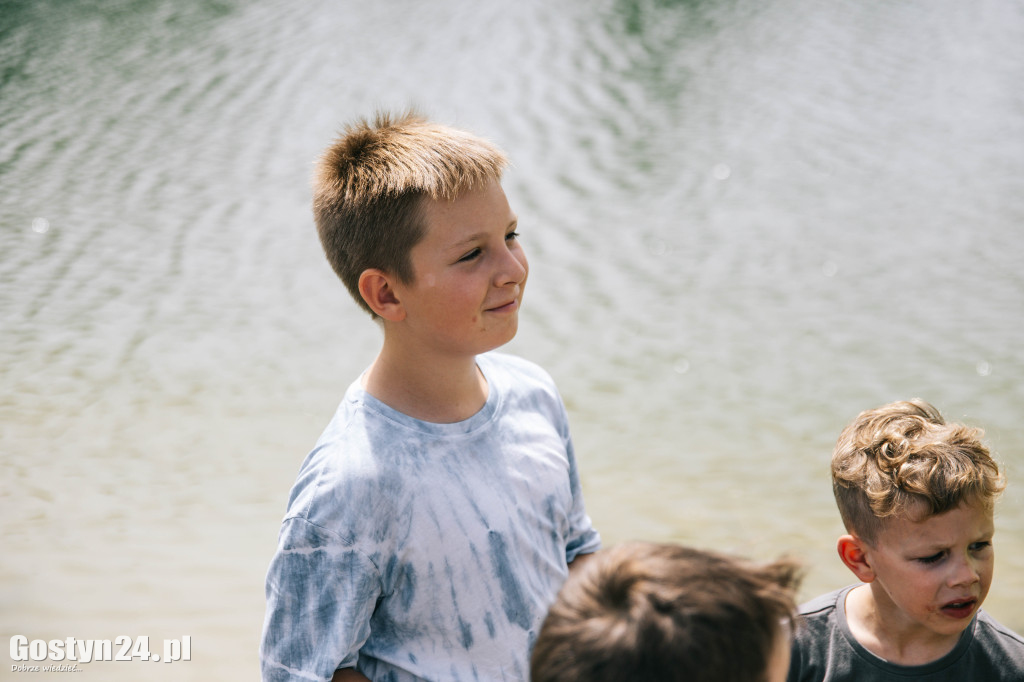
{"left": 787, "top": 585, "right": 1024, "bottom": 682}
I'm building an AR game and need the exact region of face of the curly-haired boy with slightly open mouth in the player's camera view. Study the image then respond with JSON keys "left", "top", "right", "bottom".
{"left": 865, "top": 504, "right": 995, "bottom": 636}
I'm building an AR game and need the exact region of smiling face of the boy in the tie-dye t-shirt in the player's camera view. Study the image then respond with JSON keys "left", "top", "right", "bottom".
{"left": 396, "top": 181, "right": 529, "bottom": 355}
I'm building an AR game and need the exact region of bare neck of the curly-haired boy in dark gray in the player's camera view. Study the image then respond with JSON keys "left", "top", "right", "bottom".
{"left": 846, "top": 583, "right": 964, "bottom": 666}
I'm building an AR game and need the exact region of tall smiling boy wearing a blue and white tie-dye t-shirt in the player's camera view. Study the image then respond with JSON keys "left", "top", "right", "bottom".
{"left": 261, "top": 114, "right": 600, "bottom": 682}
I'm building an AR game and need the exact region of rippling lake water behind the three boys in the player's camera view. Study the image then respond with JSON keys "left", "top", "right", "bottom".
{"left": 0, "top": 0, "right": 1024, "bottom": 680}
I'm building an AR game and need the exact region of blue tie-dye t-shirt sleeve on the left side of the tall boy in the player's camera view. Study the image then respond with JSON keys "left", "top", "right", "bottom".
{"left": 260, "top": 518, "right": 381, "bottom": 682}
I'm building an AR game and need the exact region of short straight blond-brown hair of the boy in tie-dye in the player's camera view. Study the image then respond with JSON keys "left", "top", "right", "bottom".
{"left": 313, "top": 113, "right": 508, "bottom": 315}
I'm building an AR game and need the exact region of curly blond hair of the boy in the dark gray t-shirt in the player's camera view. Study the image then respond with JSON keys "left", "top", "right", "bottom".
{"left": 831, "top": 398, "right": 1005, "bottom": 544}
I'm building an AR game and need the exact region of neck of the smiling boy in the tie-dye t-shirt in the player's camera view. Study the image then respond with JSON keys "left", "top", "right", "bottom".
{"left": 362, "top": 343, "right": 487, "bottom": 424}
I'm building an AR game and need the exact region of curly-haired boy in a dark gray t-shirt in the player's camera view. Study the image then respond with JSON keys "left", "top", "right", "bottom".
{"left": 790, "top": 399, "right": 1024, "bottom": 682}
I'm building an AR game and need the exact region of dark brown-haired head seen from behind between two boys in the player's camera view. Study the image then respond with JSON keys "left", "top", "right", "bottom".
{"left": 530, "top": 543, "right": 799, "bottom": 682}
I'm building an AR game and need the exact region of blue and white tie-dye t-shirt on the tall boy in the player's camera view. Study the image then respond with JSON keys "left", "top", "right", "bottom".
{"left": 260, "top": 352, "right": 600, "bottom": 682}
